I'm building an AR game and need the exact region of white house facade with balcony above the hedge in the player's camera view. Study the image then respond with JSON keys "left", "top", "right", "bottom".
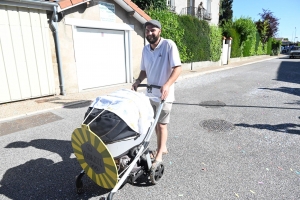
{"left": 167, "top": 0, "right": 220, "bottom": 25}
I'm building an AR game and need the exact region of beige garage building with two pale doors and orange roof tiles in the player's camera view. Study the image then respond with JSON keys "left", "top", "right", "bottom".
{"left": 0, "top": 0, "right": 150, "bottom": 103}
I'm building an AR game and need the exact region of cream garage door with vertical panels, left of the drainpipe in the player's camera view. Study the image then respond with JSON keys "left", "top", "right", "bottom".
{"left": 0, "top": 5, "right": 55, "bottom": 103}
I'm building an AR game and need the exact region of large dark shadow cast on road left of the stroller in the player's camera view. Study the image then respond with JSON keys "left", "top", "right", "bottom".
{"left": 0, "top": 139, "right": 109, "bottom": 199}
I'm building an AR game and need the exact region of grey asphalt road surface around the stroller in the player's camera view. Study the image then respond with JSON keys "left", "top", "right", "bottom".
{"left": 0, "top": 58, "right": 300, "bottom": 200}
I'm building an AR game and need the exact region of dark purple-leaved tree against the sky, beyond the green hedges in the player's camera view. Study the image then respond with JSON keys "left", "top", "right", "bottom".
{"left": 256, "top": 9, "right": 279, "bottom": 44}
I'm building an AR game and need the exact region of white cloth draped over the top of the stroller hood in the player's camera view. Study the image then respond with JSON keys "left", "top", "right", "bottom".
{"left": 90, "top": 89, "right": 154, "bottom": 134}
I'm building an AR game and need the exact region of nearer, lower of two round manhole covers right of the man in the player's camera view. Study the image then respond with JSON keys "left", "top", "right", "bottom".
{"left": 200, "top": 119, "right": 234, "bottom": 132}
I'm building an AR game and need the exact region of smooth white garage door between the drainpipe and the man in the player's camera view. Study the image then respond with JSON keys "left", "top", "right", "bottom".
{"left": 74, "top": 27, "right": 126, "bottom": 90}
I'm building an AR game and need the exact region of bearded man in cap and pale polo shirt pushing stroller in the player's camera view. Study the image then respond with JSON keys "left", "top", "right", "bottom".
{"left": 132, "top": 20, "right": 181, "bottom": 167}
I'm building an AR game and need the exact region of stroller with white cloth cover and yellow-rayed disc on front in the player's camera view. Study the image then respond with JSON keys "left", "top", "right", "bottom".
{"left": 71, "top": 84, "right": 164, "bottom": 200}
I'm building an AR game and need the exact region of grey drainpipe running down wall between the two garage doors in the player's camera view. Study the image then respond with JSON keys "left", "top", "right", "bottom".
{"left": 51, "top": 6, "right": 65, "bottom": 95}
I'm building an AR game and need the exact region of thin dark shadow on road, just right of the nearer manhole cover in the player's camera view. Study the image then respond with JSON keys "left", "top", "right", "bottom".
{"left": 235, "top": 123, "right": 300, "bottom": 135}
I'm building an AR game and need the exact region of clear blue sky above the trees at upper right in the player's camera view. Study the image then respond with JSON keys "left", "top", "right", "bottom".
{"left": 232, "top": 0, "right": 300, "bottom": 41}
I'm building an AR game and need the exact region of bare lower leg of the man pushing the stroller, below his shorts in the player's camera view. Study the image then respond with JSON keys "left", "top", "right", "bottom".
{"left": 155, "top": 123, "right": 168, "bottom": 161}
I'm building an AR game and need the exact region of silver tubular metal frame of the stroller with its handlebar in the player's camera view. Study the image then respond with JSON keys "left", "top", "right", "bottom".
{"left": 75, "top": 84, "right": 165, "bottom": 200}
